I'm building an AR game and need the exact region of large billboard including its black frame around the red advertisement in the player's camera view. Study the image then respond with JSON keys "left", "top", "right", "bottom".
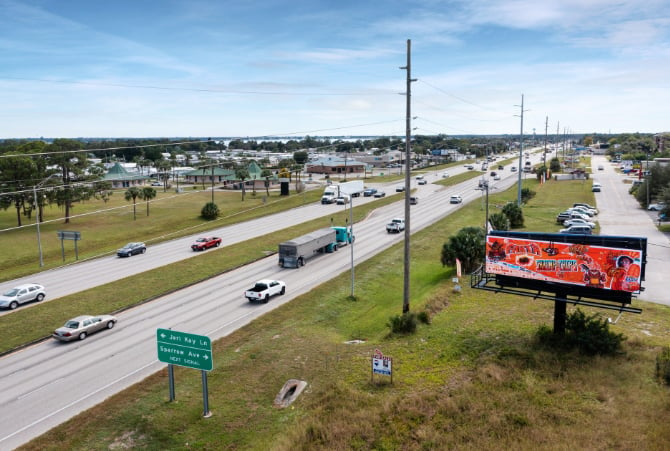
{"left": 486, "top": 231, "right": 647, "bottom": 302}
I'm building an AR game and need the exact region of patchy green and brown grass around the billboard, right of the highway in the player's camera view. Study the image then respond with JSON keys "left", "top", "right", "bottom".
{"left": 15, "top": 180, "right": 670, "bottom": 450}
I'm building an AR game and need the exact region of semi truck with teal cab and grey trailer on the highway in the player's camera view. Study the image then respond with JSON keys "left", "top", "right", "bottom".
{"left": 279, "top": 227, "right": 354, "bottom": 268}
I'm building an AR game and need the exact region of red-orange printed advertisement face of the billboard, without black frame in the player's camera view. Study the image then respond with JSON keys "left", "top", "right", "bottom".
{"left": 486, "top": 235, "right": 642, "bottom": 293}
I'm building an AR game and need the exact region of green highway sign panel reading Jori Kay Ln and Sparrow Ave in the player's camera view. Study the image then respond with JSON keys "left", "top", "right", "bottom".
{"left": 156, "top": 329, "right": 213, "bottom": 371}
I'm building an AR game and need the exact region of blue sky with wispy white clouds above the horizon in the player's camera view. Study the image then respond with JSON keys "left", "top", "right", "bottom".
{"left": 0, "top": 0, "right": 670, "bottom": 139}
